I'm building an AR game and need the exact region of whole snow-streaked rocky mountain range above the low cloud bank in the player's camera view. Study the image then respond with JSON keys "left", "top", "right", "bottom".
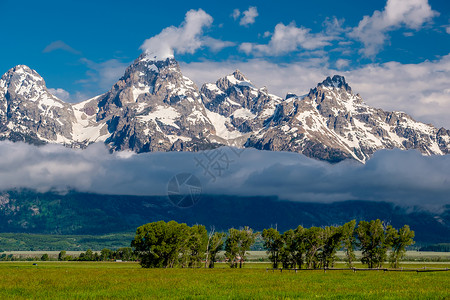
{"left": 0, "top": 53, "right": 450, "bottom": 163}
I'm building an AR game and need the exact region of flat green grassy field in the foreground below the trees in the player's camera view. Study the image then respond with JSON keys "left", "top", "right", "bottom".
{"left": 0, "top": 262, "right": 450, "bottom": 299}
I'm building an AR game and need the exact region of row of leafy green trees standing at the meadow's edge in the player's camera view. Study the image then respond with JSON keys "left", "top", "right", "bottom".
{"left": 131, "top": 220, "right": 414, "bottom": 269}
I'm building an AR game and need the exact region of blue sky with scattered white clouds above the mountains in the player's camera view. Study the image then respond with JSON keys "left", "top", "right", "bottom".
{"left": 0, "top": 0, "right": 450, "bottom": 128}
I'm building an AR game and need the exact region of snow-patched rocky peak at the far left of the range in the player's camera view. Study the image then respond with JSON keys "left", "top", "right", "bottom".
{"left": 0, "top": 65, "right": 75, "bottom": 144}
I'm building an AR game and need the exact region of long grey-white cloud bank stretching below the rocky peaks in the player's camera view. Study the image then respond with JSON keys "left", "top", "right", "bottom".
{"left": 0, "top": 142, "right": 450, "bottom": 209}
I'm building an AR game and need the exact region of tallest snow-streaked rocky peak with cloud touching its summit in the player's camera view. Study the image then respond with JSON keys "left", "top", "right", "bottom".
{"left": 91, "top": 53, "right": 215, "bottom": 152}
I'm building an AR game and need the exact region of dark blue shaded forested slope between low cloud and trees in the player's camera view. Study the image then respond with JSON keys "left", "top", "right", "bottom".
{"left": 0, "top": 190, "right": 450, "bottom": 244}
